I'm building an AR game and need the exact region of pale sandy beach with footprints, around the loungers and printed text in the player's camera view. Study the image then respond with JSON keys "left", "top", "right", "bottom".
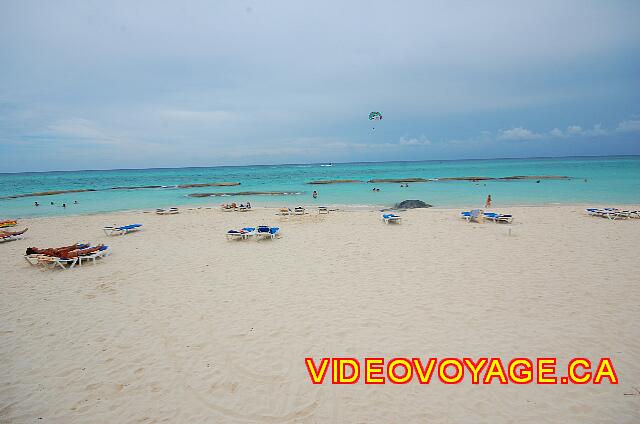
{"left": 0, "top": 205, "right": 640, "bottom": 424}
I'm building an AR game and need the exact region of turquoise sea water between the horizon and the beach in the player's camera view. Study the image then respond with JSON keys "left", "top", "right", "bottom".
{"left": 0, "top": 156, "right": 640, "bottom": 218}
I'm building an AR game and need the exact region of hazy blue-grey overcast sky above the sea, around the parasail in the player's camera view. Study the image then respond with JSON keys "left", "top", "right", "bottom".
{"left": 0, "top": 0, "right": 640, "bottom": 172}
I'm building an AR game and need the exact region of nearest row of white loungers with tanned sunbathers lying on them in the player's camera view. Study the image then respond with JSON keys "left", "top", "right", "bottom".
{"left": 24, "top": 243, "right": 109, "bottom": 270}
